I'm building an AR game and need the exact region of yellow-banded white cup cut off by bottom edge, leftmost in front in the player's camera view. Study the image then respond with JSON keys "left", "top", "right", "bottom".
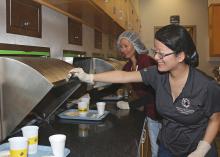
{"left": 8, "top": 137, "right": 28, "bottom": 157}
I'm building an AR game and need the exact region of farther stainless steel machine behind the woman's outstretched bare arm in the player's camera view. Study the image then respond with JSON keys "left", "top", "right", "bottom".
{"left": 73, "top": 57, "right": 126, "bottom": 89}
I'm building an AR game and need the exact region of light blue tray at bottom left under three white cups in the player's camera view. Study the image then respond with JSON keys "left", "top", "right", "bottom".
{"left": 0, "top": 143, "right": 70, "bottom": 157}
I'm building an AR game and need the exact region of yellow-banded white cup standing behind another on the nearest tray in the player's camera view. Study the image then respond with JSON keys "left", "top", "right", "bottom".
{"left": 21, "top": 125, "right": 39, "bottom": 154}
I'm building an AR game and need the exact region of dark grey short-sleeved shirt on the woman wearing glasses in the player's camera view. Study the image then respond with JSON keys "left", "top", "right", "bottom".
{"left": 140, "top": 66, "right": 220, "bottom": 157}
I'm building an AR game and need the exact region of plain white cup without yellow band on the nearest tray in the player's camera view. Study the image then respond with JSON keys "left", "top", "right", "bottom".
{"left": 49, "top": 134, "right": 66, "bottom": 157}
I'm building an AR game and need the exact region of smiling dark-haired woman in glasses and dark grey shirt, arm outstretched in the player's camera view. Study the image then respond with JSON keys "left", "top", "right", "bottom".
{"left": 70, "top": 25, "right": 220, "bottom": 157}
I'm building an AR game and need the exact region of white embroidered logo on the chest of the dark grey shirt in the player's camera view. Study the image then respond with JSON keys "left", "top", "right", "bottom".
{"left": 176, "top": 98, "right": 195, "bottom": 115}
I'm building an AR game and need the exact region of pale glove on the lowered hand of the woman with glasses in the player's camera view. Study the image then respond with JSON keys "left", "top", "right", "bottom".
{"left": 187, "top": 141, "right": 211, "bottom": 157}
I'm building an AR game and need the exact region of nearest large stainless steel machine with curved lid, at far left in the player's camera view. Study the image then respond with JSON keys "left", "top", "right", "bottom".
{"left": 0, "top": 57, "right": 80, "bottom": 141}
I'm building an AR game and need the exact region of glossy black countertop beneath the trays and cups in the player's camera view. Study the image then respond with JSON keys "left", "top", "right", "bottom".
{"left": 39, "top": 103, "right": 145, "bottom": 157}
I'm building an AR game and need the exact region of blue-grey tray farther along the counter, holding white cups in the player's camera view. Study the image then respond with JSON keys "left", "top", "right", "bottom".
{"left": 58, "top": 109, "right": 109, "bottom": 121}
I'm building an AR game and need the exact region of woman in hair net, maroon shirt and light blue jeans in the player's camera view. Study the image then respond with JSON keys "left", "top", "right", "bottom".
{"left": 117, "top": 31, "right": 161, "bottom": 157}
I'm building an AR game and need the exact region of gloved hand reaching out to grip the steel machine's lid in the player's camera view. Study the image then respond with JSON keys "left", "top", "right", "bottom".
{"left": 69, "top": 68, "right": 94, "bottom": 84}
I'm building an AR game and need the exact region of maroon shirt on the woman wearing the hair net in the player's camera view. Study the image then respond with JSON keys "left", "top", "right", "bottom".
{"left": 123, "top": 54, "right": 157, "bottom": 119}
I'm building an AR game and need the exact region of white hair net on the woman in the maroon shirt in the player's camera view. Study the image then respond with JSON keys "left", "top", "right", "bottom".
{"left": 117, "top": 31, "right": 148, "bottom": 54}
